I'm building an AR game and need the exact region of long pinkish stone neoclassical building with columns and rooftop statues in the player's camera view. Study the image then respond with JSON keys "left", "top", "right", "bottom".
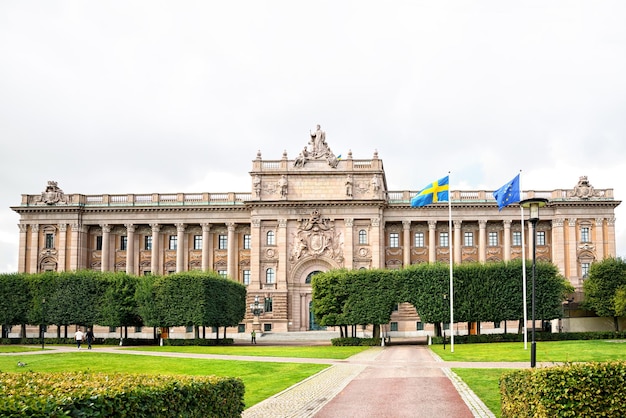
{"left": 12, "top": 126, "right": 620, "bottom": 332}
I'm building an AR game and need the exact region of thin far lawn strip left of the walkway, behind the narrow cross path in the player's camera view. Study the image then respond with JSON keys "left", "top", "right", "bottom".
{"left": 124, "top": 345, "right": 370, "bottom": 360}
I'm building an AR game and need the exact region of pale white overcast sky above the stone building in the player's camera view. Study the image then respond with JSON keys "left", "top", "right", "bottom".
{"left": 0, "top": 0, "right": 626, "bottom": 272}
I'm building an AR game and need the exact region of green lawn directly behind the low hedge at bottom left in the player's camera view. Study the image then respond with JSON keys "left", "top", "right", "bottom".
{"left": 0, "top": 350, "right": 328, "bottom": 408}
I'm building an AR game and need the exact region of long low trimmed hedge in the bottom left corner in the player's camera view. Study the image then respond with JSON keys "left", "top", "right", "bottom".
{"left": 0, "top": 372, "right": 245, "bottom": 417}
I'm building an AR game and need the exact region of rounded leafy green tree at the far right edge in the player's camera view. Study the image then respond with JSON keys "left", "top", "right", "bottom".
{"left": 583, "top": 258, "right": 626, "bottom": 331}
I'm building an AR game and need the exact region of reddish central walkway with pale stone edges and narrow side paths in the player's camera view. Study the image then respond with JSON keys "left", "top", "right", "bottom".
{"left": 3, "top": 345, "right": 528, "bottom": 418}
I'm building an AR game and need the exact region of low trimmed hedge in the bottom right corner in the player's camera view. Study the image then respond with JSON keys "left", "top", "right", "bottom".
{"left": 500, "top": 361, "right": 626, "bottom": 418}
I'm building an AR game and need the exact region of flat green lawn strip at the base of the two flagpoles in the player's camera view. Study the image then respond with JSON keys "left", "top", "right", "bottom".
{"left": 430, "top": 340, "right": 626, "bottom": 365}
